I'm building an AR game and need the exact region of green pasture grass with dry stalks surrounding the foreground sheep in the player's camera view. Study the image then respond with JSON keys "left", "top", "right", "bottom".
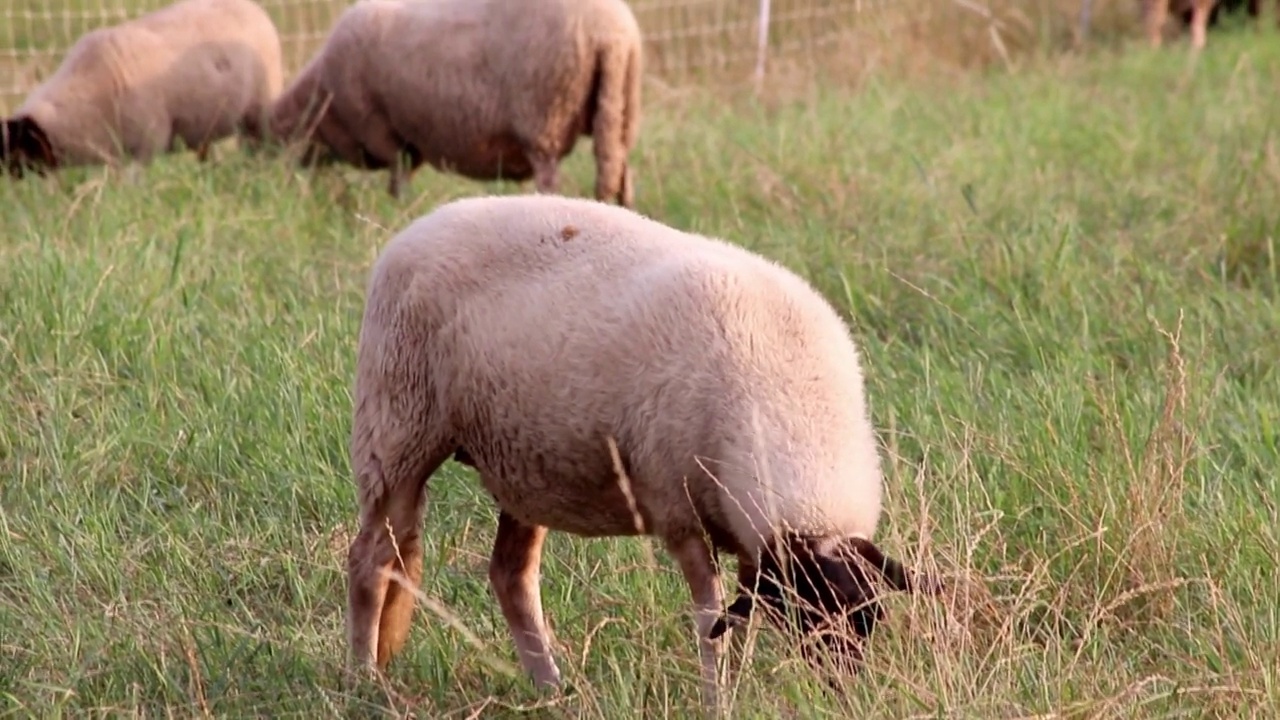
{"left": 0, "top": 25, "right": 1280, "bottom": 719}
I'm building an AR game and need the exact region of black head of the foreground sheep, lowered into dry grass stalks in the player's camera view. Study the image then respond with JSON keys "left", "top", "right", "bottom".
{"left": 710, "top": 538, "right": 931, "bottom": 671}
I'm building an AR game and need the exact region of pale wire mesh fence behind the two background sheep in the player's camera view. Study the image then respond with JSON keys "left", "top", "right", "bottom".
{"left": 0, "top": 0, "right": 902, "bottom": 111}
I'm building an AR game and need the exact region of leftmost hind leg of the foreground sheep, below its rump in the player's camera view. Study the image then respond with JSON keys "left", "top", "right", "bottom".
{"left": 347, "top": 446, "right": 452, "bottom": 670}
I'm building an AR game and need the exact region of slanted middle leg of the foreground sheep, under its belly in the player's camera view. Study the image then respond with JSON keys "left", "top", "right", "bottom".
{"left": 489, "top": 512, "right": 561, "bottom": 687}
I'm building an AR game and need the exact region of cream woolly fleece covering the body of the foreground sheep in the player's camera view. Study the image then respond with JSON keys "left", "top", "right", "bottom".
{"left": 351, "top": 195, "right": 881, "bottom": 552}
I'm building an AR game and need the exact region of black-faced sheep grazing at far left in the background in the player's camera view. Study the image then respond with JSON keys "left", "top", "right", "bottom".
{"left": 3, "top": 0, "right": 284, "bottom": 177}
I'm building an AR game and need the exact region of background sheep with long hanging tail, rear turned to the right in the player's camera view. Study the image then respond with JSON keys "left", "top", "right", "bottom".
{"left": 263, "top": 0, "right": 643, "bottom": 208}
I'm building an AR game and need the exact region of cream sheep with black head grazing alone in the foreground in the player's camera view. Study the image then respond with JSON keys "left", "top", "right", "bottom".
{"left": 347, "top": 195, "right": 940, "bottom": 705}
